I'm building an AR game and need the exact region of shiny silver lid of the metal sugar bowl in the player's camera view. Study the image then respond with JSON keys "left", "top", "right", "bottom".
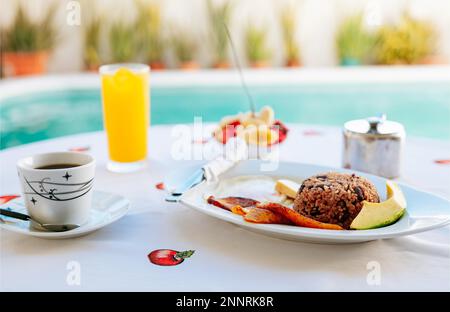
{"left": 344, "top": 114, "right": 405, "bottom": 137}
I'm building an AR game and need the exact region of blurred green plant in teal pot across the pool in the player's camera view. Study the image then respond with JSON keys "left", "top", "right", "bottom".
{"left": 336, "top": 14, "right": 376, "bottom": 66}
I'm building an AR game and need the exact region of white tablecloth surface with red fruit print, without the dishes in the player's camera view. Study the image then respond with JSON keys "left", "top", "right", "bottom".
{"left": 0, "top": 126, "right": 450, "bottom": 291}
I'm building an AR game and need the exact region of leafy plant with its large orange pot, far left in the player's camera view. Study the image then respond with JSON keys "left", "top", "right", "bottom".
{"left": 1, "top": 6, "right": 57, "bottom": 76}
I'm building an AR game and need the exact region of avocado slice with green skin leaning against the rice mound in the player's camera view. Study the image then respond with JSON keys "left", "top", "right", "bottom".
{"left": 350, "top": 180, "right": 406, "bottom": 230}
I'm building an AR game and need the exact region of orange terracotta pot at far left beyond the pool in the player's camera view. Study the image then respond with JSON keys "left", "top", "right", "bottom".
{"left": 3, "top": 51, "right": 48, "bottom": 76}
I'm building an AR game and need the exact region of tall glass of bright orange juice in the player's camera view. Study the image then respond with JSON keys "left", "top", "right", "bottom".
{"left": 100, "top": 64, "right": 150, "bottom": 172}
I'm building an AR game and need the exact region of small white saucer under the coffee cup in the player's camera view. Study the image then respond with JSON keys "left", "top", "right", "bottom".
{"left": 0, "top": 191, "right": 130, "bottom": 239}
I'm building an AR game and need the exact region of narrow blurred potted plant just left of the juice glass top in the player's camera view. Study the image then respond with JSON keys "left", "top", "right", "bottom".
{"left": 83, "top": 16, "right": 103, "bottom": 71}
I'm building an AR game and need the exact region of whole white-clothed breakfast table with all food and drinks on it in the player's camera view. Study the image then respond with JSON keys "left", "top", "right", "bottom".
{"left": 0, "top": 64, "right": 450, "bottom": 292}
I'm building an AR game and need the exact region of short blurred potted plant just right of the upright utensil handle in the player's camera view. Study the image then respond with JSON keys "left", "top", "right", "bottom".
{"left": 245, "top": 24, "right": 272, "bottom": 68}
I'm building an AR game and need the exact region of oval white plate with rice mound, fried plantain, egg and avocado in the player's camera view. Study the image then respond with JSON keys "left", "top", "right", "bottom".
{"left": 180, "top": 160, "right": 450, "bottom": 244}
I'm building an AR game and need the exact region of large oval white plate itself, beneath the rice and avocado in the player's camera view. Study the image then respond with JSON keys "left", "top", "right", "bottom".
{"left": 181, "top": 161, "right": 450, "bottom": 244}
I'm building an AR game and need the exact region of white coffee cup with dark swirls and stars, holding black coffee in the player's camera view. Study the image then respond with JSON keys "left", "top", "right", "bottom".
{"left": 17, "top": 152, "right": 95, "bottom": 227}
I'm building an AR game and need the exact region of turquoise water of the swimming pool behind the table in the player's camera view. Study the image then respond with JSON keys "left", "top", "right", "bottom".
{"left": 0, "top": 83, "right": 450, "bottom": 149}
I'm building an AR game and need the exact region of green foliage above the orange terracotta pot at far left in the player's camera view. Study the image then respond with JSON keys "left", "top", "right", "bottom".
{"left": 1, "top": 5, "right": 57, "bottom": 52}
